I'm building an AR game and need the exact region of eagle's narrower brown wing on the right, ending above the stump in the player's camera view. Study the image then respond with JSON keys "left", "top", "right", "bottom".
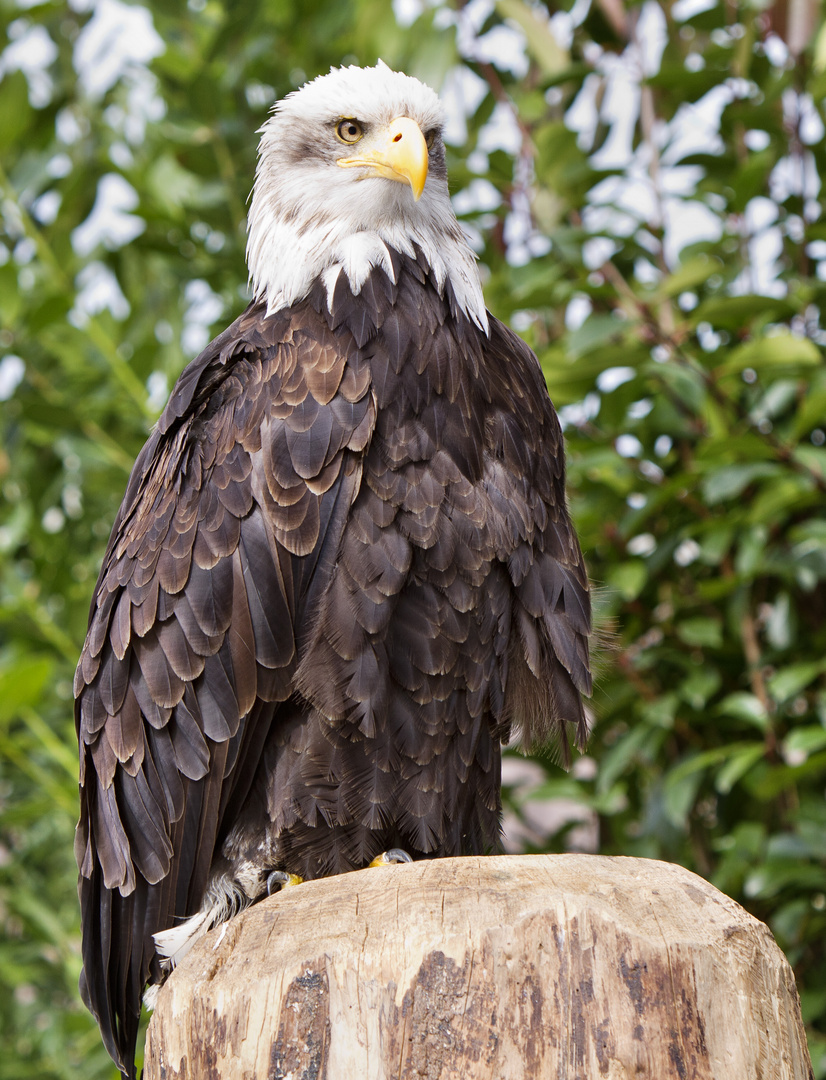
{"left": 485, "top": 316, "right": 592, "bottom": 751}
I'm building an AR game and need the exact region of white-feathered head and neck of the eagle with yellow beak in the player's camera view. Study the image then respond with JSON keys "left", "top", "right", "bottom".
{"left": 247, "top": 62, "right": 488, "bottom": 330}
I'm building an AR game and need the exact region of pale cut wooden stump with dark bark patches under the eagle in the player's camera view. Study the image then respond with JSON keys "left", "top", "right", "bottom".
{"left": 145, "top": 855, "right": 812, "bottom": 1080}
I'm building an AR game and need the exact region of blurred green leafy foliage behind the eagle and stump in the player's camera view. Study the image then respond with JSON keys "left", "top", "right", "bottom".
{"left": 0, "top": 0, "right": 826, "bottom": 1080}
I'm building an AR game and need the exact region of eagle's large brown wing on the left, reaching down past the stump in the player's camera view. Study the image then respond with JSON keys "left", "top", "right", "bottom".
{"left": 76, "top": 308, "right": 375, "bottom": 1076}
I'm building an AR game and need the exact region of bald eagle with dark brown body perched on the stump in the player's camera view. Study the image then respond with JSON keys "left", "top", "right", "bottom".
{"left": 75, "top": 64, "right": 591, "bottom": 1077}
